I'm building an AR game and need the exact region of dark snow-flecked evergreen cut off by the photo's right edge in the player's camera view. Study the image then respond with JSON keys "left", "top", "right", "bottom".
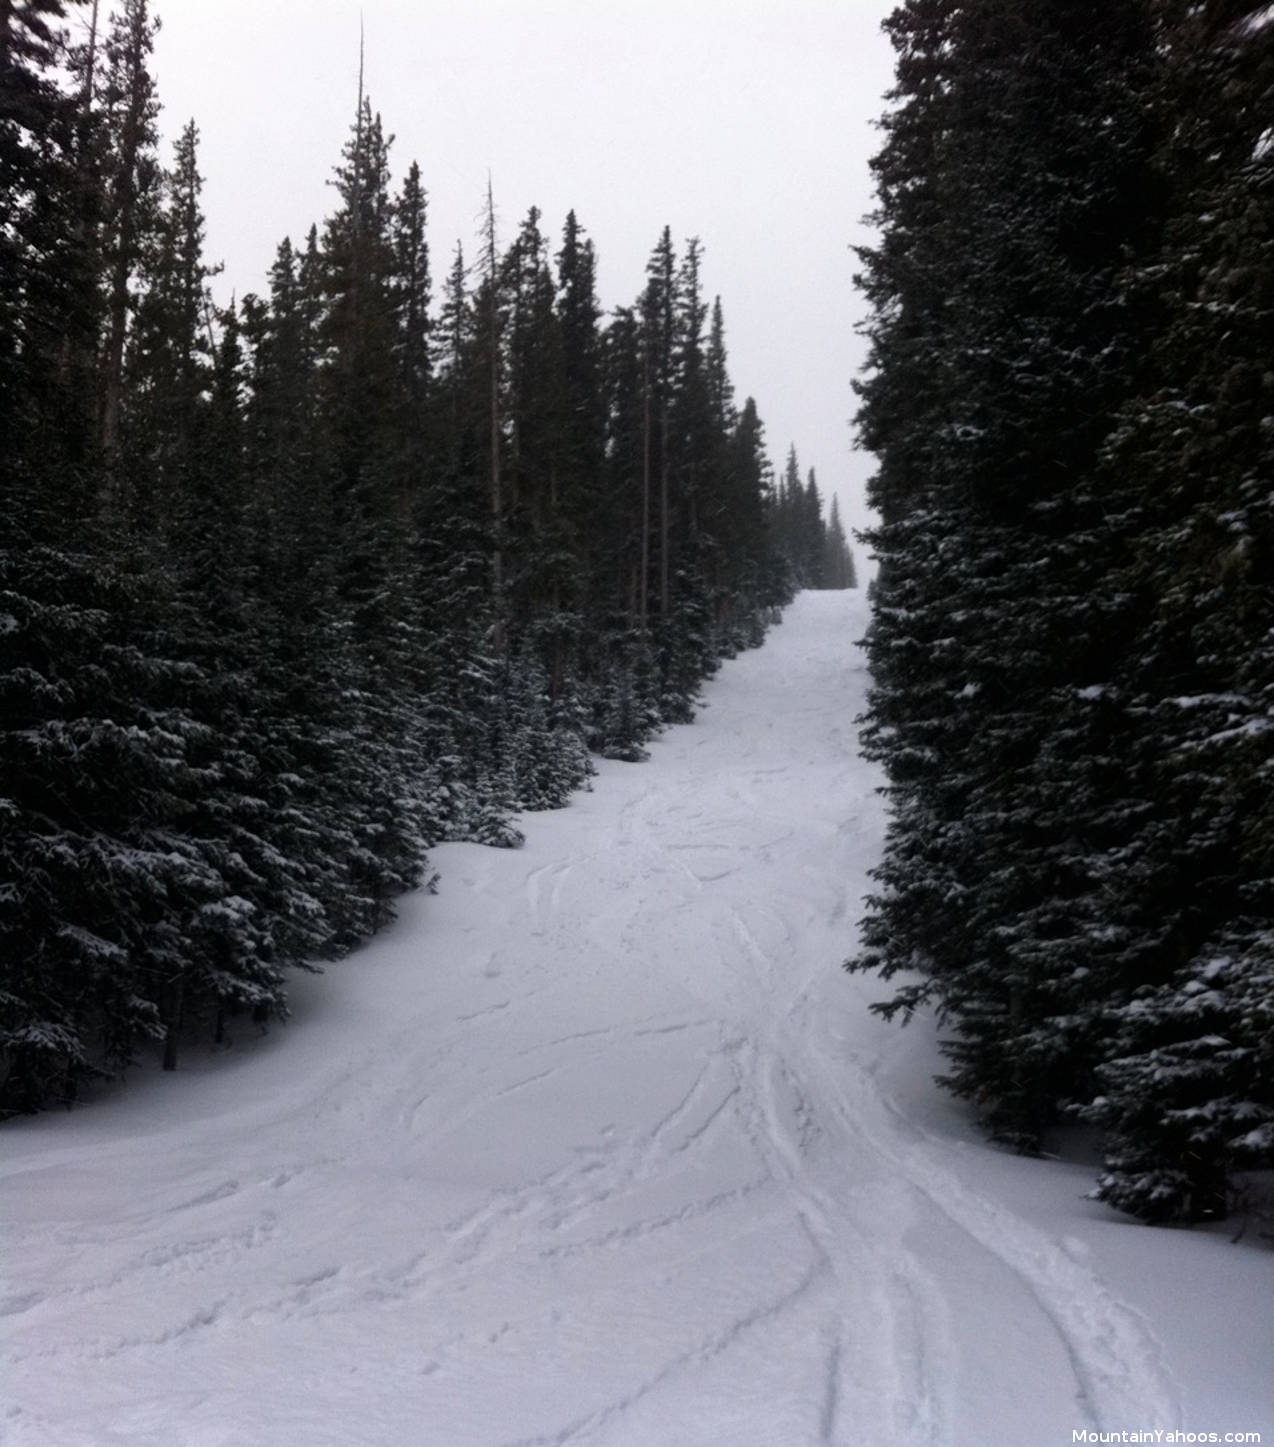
{"left": 1087, "top": 4, "right": 1274, "bottom": 1220}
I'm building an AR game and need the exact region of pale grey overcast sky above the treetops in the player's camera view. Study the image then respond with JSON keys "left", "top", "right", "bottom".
{"left": 136, "top": 0, "right": 893, "bottom": 551}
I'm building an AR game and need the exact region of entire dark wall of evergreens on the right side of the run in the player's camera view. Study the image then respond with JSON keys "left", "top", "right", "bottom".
{"left": 851, "top": 0, "right": 1274, "bottom": 1220}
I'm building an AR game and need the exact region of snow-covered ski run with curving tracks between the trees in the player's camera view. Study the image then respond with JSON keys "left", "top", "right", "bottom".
{"left": 0, "top": 593, "right": 1274, "bottom": 1447}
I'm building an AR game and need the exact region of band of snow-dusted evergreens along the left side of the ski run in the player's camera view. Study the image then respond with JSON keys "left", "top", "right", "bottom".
{"left": 0, "top": 0, "right": 857, "bottom": 1114}
